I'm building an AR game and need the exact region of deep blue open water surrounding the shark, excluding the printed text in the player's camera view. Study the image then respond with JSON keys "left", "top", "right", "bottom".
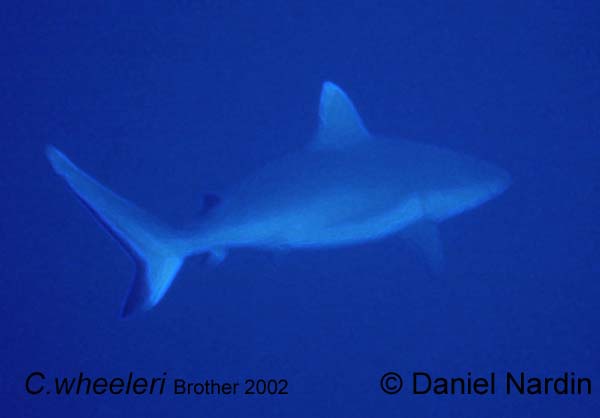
{"left": 0, "top": 1, "right": 600, "bottom": 418}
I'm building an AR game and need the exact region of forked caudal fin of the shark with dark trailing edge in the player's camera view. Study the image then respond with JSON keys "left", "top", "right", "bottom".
{"left": 46, "top": 146, "right": 185, "bottom": 317}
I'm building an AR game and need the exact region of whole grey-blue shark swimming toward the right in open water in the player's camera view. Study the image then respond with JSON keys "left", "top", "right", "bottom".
{"left": 46, "top": 81, "right": 510, "bottom": 317}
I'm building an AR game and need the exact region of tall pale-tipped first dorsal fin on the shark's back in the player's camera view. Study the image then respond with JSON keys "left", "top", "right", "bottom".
{"left": 314, "top": 81, "right": 370, "bottom": 148}
